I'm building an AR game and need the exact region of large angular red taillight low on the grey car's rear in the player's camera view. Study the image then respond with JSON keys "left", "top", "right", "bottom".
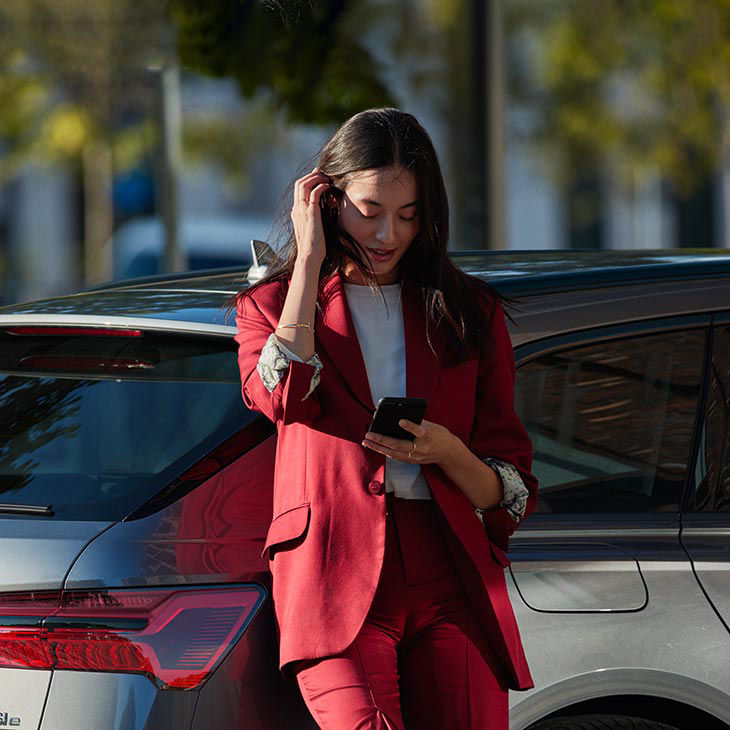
{"left": 0, "top": 585, "right": 265, "bottom": 689}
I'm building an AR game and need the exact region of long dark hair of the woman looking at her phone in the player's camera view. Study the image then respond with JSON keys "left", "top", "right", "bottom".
{"left": 233, "top": 108, "right": 505, "bottom": 356}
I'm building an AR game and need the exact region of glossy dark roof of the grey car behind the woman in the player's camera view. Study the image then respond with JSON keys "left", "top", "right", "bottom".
{"left": 0, "top": 249, "right": 730, "bottom": 341}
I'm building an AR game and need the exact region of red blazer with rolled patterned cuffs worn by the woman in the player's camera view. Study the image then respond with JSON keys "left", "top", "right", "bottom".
{"left": 236, "top": 274, "right": 537, "bottom": 689}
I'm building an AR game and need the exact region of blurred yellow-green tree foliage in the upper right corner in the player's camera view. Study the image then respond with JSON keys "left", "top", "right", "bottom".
{"left": 506, "top": 0, "right": 730, "bottom": 215}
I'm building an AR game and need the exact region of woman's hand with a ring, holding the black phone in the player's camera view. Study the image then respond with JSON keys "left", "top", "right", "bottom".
{"left": 362, "top": 418, "right": 463, "bottom": 465}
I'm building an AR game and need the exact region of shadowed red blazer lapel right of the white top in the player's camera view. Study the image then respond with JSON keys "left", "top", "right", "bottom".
{"left": 403, "top": 278, "right": 446, "bottom": 400}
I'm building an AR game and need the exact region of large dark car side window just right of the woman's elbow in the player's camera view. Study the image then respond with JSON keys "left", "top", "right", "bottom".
{"left": 515, "top": 329, "right": 706, "bottom": 513}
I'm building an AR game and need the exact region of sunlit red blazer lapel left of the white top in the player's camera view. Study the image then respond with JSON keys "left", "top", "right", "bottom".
{"left": 316, "top": 272, "right": 375, "bottom": 413}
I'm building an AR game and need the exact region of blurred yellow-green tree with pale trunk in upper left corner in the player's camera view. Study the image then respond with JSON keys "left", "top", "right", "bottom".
{"left": 0, "top": 0, "right": 174, "bottom": 283}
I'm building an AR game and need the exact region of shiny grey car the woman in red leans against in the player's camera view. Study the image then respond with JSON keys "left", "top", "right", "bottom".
{"left": 0, "top": 251, "right": 730, "bottom": 730}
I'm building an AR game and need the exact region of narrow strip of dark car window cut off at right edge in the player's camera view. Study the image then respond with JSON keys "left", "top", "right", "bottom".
{"left": 689, "top": 324, "right": 730, "bottom": 512}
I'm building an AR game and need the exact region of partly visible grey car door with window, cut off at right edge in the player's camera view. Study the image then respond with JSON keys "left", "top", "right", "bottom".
{"left": 682, "top": 312, "right": 730, "bottom": 628}
